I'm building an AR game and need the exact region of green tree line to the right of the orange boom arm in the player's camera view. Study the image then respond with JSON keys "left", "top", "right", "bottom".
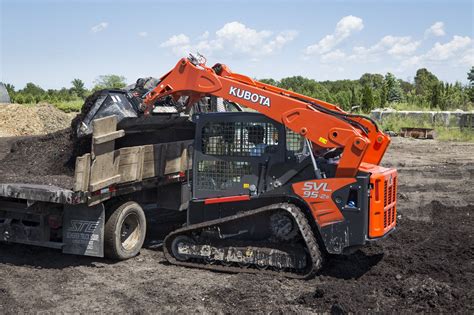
{"left": 260, "top": 67, "right": 474, "bottom": 113}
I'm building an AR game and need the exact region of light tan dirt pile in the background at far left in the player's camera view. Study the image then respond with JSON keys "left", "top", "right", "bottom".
{"left": 0, "top": 103, "right": 74, "bottom": 137}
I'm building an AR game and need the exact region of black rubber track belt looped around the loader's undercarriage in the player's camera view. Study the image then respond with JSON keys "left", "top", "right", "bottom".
{"left": 163, "top": 203, "right": 322, "bottom": 279}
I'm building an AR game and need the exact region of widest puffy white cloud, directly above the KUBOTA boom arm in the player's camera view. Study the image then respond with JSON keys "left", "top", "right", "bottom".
{"left": 160, "top": 22, "right": 298, "bottom": 59}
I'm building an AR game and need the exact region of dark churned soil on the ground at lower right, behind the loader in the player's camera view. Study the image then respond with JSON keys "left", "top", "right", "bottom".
{"left": 295, "top": 202, "right": 474, "bottom": 313}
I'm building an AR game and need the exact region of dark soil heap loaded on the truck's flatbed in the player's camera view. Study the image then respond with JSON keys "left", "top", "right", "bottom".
{"left": 0, "top": 128, "right": 75, "bottom": 189}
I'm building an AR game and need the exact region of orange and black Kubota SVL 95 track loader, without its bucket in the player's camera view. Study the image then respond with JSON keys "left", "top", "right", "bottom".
{"left": 144, "top": 56, "right": 397, "bottom": 278}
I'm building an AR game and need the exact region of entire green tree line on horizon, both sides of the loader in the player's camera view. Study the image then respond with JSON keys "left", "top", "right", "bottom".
{"left": 6, "top": 67, "right": 474, "bottom": 112}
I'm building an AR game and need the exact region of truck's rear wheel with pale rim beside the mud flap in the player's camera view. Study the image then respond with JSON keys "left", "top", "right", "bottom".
{"left": 104, "top": 201, "right": 146, "bottom": 260}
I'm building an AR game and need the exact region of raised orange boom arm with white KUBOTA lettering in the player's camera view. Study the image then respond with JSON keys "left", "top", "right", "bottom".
{"left": 144, "top": 58, "right": 390, "bottom": 177}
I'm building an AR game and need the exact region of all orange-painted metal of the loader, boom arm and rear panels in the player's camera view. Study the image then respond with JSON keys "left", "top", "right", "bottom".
{"left": 144, "top": 58, "right": 397, "bottom": 238}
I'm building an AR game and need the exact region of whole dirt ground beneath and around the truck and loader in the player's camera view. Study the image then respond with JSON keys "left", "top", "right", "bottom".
{"left": 0, "top": 138, "right": 474, "bottom": 314}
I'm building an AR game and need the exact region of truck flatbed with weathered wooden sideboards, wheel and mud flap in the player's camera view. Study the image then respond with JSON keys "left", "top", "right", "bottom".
{"left": 0, "top": 116, "right": 193, "bottom": 260}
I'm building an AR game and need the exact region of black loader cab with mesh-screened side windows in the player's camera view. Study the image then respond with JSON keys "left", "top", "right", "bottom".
{"left": 192, "top": 112, "right": 305, "bottom": 199}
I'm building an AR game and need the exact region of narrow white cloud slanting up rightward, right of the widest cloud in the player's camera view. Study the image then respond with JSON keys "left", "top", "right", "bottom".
{"left": 305, "top": 15, "right": 364, "bottom": 55}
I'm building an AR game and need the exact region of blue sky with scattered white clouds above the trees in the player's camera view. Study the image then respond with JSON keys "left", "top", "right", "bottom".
{"left": 0, "top": 0, "right": 474, "bottom": 88}
